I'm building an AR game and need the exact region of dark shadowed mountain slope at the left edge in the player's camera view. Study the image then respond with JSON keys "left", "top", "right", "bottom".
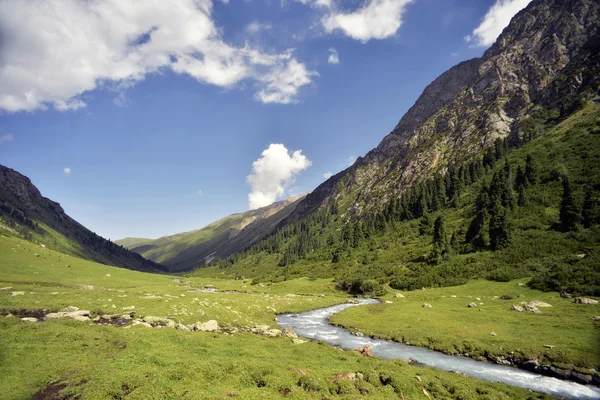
{"left": 0, "top": 165, "right": 165, "bottom": 272}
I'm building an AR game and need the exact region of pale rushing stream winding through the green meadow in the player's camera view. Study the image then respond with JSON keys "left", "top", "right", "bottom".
{"left": 277, "top": 299, "right": 600, "bottom": 399}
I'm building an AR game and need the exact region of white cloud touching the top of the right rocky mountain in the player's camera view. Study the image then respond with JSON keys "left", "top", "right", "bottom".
{"left": 465, "top": 0, "right": 531, "bottom": 47}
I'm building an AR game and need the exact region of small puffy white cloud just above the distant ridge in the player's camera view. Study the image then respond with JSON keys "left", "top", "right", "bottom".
{"left": 246, "top": 143, "right": 311, "bottom": 210}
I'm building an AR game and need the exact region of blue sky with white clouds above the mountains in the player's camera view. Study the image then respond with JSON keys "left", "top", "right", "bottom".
{"left": 0, "top": 0, "right": 530, "bottom": 240}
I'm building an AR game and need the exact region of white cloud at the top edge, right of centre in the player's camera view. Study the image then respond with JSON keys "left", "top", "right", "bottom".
{"left": 321, "top": 0, "right": 413, "bottom": 42}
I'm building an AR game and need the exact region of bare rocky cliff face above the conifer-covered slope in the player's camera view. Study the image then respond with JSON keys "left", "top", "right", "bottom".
{"left": 284, "top": 0, "right": 600, "bottom": 224}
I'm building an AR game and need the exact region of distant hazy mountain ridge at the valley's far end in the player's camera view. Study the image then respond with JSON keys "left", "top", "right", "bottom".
{"left": 115, "top": 195, "right": 306, "bottom": 271}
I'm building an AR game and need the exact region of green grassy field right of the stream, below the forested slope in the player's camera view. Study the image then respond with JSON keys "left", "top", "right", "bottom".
{"left": 332, "top": 279, "right": 600, "bottom": 369}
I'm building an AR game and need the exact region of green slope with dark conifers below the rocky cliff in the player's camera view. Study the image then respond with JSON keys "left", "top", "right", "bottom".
{"left": 193, "top": 103, "right": 600, "bottom": 296}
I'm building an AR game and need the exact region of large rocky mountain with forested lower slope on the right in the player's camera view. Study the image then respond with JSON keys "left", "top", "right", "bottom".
{"left": 196, "top": 0, "right": 600, "bottom": 293}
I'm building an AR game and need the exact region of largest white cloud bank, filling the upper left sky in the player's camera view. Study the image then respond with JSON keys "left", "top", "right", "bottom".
{"left": 0, "top": 0, "right": 315, "bottom": 112}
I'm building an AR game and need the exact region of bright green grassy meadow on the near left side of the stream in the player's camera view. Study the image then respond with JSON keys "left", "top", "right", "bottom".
{"left": 0, "top": 236, "right": 547, "bottom": 400}
